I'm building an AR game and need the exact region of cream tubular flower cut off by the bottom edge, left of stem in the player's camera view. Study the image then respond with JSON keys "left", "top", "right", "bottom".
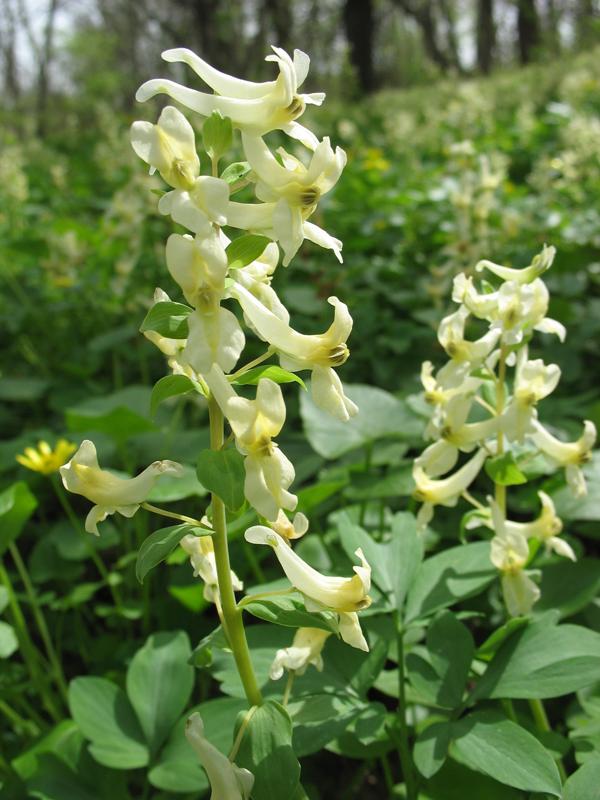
{"left": 185, "top": 711, "right": 254, "bottom": 800}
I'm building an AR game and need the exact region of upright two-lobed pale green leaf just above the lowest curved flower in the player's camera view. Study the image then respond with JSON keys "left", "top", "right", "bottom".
{"left": 337, "top": 512, "right": 423, "bottom": 608}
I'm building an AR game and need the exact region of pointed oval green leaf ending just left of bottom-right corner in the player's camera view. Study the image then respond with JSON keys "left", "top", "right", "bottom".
{"left": 450, "top": 711, "right": 561, "bottom": 797}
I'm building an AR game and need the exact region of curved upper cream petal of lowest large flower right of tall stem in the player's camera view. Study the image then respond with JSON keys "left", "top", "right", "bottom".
{"left": 245, "top": 525, "right": 371, "bottom": 612}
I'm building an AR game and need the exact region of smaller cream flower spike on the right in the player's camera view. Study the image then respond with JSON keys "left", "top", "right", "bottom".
{"left": 413, "top": 247, "right": 596, "bottom": 616}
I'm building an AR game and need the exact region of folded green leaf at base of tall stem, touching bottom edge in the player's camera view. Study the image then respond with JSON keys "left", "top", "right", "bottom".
{"left": 235, "top": 700, "right": 300, "bottom": 800}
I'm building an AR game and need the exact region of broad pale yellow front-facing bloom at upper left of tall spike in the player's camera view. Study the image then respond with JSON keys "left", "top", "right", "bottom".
{"left": 131, "top": 106, "right": 200, "bottom": 190}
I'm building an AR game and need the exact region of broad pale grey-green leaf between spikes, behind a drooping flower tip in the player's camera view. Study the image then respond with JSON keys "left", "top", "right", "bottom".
{"left": 300, "top": 384, "right": 424, "bottom": 458}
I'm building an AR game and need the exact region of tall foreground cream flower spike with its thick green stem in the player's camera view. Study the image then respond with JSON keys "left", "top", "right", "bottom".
{"left": 61, "top": 48, "right": 371, "bottom": 800}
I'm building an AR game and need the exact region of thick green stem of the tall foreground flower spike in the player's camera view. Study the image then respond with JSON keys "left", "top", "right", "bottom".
{"left": 208, "top": 397, "right": 263, "bottom": 706}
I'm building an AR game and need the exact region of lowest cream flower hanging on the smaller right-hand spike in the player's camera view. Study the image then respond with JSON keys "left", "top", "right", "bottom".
{"left": 489, "top": 498, "right": 540, "bottom": 617}
